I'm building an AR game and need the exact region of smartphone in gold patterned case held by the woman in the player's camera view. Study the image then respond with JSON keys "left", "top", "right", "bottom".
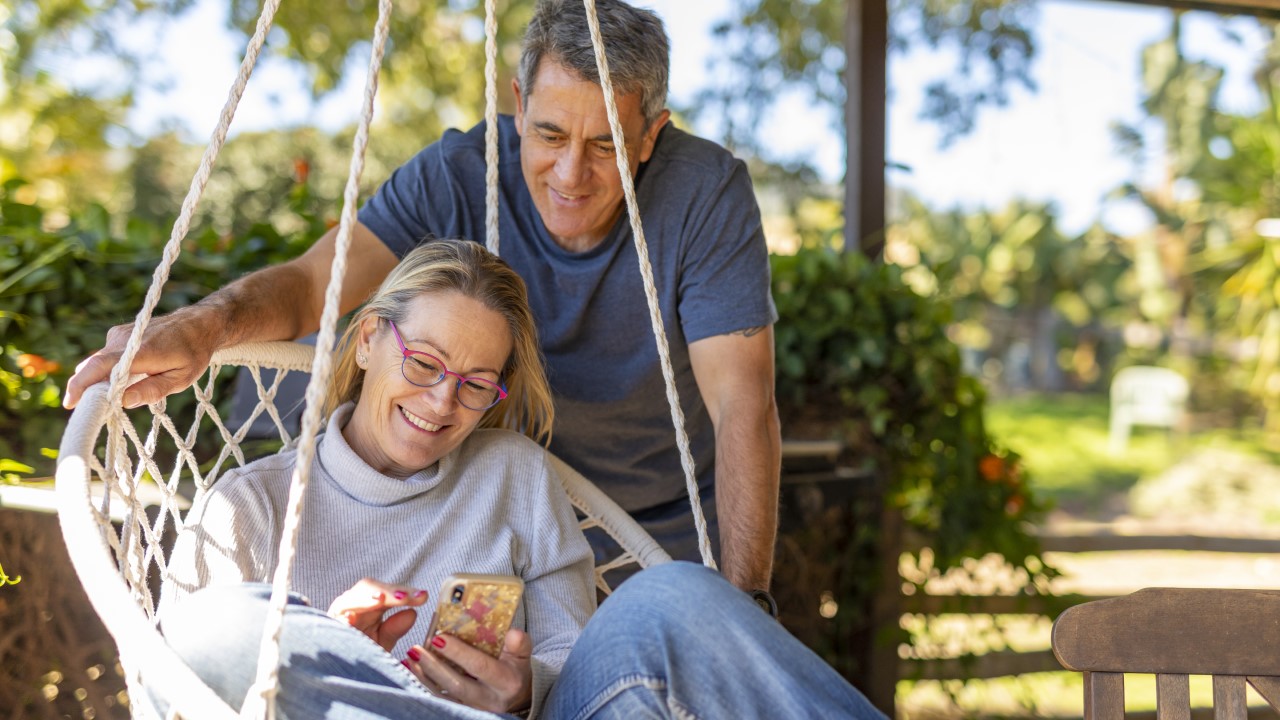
{"left": 426, "top": 573, "right": 525, "bottom": 657}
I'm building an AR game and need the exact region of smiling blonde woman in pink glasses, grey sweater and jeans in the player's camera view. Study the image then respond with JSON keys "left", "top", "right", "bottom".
{"left": 152, "top": 241, "right": 883, "bottom": 720}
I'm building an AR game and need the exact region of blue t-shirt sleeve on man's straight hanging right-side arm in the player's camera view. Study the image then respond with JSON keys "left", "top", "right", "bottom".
{"left": 680, "top": 155, "right": 778, "bottom": 342}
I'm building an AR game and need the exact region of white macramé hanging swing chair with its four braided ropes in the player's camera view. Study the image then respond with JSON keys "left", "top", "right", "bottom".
{"left": 56, "top": 0, "right": 714, "bottom": 719}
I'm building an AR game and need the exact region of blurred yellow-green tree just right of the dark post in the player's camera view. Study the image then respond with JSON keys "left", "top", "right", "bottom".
{"left": 886, "top": 190, "right": 1133, "bottom": 391}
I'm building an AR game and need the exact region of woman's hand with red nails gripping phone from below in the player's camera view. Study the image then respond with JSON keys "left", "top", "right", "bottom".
{"left": 404, "top": 629, "right": 534, "bottom": 712}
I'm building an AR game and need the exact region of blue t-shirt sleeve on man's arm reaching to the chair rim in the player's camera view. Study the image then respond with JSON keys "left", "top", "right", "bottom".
{"left": 358, "top": 131, "right": 465, "bottom": 258}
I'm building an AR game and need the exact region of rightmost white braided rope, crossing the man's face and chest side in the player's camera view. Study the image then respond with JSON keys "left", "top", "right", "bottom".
{"left": 582, "top": 0, "right": 716, "bottom": 569}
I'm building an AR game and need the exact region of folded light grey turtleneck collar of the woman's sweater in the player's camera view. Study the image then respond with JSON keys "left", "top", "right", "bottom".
{"left": 316, "top": 402, "right": 458, "bottom": 506}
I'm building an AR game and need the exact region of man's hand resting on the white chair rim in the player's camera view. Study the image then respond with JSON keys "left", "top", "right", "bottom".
{"left": 63, "top": 307, "right": 220, "bottom": 410}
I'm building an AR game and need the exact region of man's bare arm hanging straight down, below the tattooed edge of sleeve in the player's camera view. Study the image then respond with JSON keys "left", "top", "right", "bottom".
{"left": 689, "top": 325, "right": 782, "bottom": 589}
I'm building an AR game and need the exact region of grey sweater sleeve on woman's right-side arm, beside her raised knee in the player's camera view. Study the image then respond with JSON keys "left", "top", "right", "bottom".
{"left": 518, "top": 448, "right": 595, "bottom": 717}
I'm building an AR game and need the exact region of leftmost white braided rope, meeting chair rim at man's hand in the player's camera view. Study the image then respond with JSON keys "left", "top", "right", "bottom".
{"left": 106, "top": 0, "right": 288, "bottom": 499}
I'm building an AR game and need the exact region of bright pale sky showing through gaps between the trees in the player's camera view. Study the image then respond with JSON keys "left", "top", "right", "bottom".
{"left": 49, "top": 0, "right": 1263, "bottom": 232}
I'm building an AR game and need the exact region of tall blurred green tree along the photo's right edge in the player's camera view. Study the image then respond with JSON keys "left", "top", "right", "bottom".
{"left": 1117, "top": 13, "right": 1280, "bottom": 443}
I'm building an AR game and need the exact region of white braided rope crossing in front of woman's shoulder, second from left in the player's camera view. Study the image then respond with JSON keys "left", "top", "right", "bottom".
{"left": 244, "top": 0, "right": 392, "bottom": 720}
